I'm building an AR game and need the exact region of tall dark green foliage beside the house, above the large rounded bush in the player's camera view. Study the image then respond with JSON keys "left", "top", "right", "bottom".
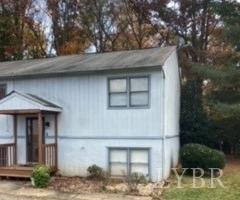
{"left": 180, "top": 79, "right": 216, "bottom": 147}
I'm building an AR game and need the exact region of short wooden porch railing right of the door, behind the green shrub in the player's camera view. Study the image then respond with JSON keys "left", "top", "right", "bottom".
{"left": 43, "top": 144, "right": 57, "bottom": 168}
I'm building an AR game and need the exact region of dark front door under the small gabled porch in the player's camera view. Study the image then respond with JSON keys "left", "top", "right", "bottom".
{"left": 26, "top": 117, "right": 44, "bottom": 163}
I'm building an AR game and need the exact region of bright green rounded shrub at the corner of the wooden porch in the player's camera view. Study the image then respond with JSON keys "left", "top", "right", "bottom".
{"left": 32, "top": 165, "right": 51, "bottom": 188}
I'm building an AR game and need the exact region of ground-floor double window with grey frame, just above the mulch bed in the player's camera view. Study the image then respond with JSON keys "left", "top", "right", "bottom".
{"left": 109, "top": 148, "right": 149, "bottom": 176}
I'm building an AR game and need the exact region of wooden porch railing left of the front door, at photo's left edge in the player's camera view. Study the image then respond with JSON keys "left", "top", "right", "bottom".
{"left": 0, "top": 143, "right": 16, "bottom": 167}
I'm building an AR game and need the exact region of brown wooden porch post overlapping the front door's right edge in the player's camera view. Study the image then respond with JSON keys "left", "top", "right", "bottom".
{"left": 38, "top": 111, "right": 43, "bottom": 164}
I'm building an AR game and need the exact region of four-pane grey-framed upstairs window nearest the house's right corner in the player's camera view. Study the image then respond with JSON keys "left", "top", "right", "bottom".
{"left": 108, "top": 76, "right": 149, "bottom": 108}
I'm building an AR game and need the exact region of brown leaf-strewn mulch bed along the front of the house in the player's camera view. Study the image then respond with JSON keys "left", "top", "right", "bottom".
{"left": 48, "top": 177, "right": 164, "bottom": 196}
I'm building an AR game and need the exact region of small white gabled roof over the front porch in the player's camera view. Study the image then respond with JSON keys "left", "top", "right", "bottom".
{"left": 0, "top": 91, "right": 62, "bottom": 114}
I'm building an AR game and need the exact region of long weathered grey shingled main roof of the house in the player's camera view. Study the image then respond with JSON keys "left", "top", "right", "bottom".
{"left": 0, "top": 46, "right": 176, "bottom": 79}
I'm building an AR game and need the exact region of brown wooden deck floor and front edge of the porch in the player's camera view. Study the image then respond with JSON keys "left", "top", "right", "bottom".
{"left": 0, "top": 166, "right": 33, "bottom": 178}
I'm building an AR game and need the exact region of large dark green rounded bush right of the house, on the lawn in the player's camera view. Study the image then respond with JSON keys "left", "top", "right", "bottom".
{"left": 180, "top": 144, "right": 226, "bottom": 171}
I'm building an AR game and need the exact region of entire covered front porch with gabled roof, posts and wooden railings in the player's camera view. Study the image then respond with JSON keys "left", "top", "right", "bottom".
{"left": 0, "top": 91, "right": 62, "bottom": 178}
